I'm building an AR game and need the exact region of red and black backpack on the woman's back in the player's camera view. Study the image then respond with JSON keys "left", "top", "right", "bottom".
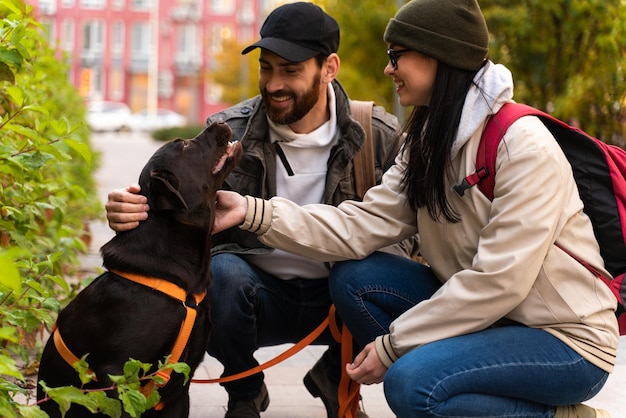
{"left": 457, "top": 103, "right": 626, "bottom": 335}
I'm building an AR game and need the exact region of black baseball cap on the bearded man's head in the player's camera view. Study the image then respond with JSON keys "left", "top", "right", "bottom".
{"left": 241, "top": 2, "right": 339, "bottom": 62}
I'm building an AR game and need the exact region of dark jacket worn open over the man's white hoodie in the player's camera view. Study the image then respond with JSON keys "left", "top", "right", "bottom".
{"left": 207, "top": 80, "right": 410, "bottom": 254}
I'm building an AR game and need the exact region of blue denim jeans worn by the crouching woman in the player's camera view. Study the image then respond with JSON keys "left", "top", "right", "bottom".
{"left": 330, "top": 252, "right": 608, "bottom": 418}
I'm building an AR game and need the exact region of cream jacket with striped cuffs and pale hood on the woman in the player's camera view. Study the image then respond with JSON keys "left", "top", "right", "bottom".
{"left": 241, "top": 63, "right": 618, "bottom": 372}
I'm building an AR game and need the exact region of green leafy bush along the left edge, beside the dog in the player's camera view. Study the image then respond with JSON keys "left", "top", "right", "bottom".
{"left": 0, "top": 0, "right": 102, "bottom": 417}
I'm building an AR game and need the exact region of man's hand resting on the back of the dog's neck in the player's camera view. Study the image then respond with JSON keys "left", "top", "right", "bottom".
{"left": 105, "top": 184, "right": 150, "bottom": 232}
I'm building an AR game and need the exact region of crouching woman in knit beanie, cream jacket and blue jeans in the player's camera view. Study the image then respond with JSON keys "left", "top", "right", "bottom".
{"left": 214, "top": 0, "right": 618, "bottom": 417}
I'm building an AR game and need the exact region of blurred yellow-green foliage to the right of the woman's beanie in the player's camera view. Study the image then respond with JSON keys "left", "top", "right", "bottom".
{"left": 480, "top": 0, "right": 626, "bottom": 147}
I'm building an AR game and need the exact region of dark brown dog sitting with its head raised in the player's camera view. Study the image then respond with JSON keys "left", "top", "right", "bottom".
{"left": 37, "top": 123, "right": 242, "bottom": 418}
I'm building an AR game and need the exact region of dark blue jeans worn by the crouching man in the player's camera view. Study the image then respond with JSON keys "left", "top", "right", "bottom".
{"left": 207, "top": 254, "right": 341, "bottom": 399}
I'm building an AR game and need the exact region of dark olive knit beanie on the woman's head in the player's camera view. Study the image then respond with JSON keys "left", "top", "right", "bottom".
{"left": 384, "top": 0, "right": 489, "bottom": 71}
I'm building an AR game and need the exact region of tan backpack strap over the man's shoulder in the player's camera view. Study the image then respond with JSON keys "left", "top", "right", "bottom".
{"left": 350, "top": 100, "right": 376, "bottom": 198}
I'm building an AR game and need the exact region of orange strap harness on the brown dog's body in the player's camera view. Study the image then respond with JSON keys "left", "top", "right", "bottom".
{"left": 52, "top": 270, "right": 206, "bottom": 410}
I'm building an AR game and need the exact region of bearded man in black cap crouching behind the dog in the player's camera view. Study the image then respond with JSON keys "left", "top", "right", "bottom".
{"left": 107, "top": 2, "right": 410, "bottom": 418}
